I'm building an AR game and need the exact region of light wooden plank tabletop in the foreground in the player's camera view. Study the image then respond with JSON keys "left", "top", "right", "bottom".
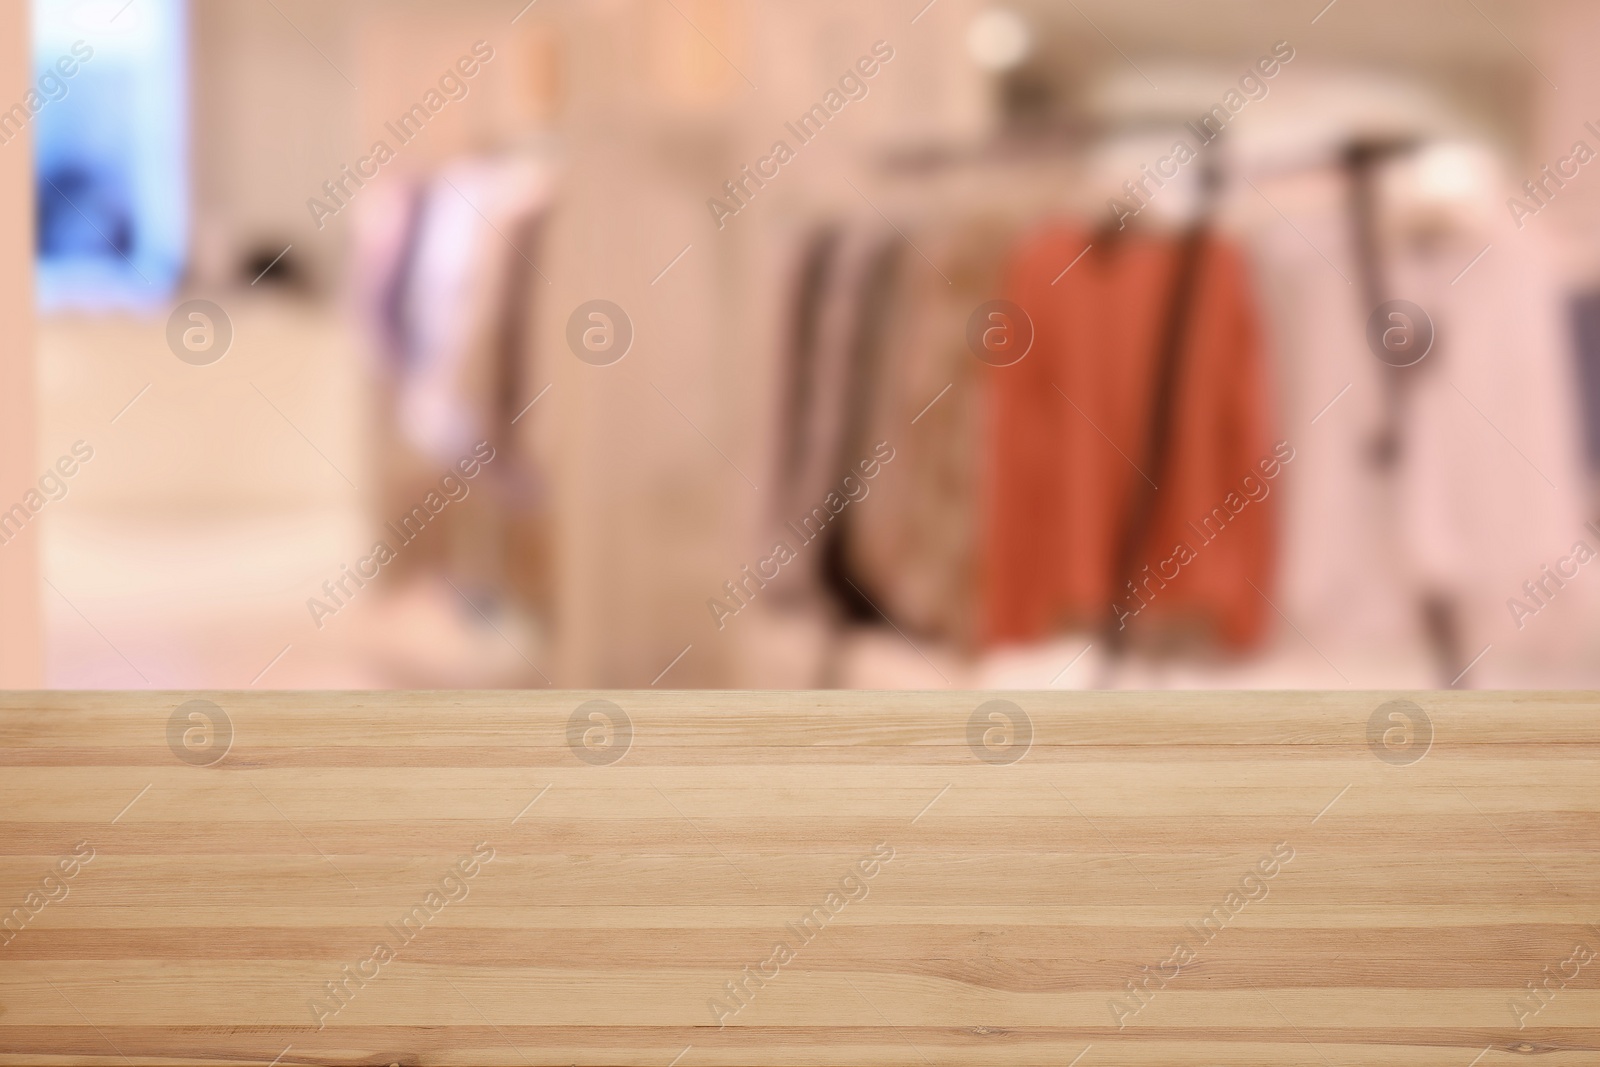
{"left": 0, "top": 691, "right": 1600, "bottom": 1067}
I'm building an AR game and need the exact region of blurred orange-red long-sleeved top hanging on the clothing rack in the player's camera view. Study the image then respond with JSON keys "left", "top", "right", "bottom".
{"left": 982, "top": 224, "right": 1293, "bottom": 648}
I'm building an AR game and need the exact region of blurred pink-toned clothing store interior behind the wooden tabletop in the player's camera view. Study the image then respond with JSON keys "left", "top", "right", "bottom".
{"left": 0, "top": 0, "right": 1600, "bottom": 689}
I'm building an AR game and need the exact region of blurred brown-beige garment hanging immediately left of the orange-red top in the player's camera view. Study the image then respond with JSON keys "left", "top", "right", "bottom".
{"left": 846, "top": 219, "right": 1014, "bottom": 646}
